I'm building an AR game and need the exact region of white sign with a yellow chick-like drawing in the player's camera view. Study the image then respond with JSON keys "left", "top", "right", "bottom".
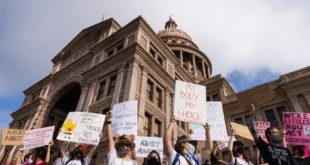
{"left": 57, "top": 112, "right": 105, "bottom": 145}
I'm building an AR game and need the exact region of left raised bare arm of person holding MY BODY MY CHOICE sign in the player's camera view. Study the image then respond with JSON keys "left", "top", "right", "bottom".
{"left": 164, "top": 115, "right": 175, "bottom": 157}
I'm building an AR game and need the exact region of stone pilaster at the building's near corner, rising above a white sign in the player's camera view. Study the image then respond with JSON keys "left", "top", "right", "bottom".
{"left": 123, "top": 63, "right": 139, "bottom": 101}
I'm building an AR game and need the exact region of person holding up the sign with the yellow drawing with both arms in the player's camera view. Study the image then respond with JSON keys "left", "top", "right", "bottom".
{"left": 58, "top": 140, "right": 97, "bottom": 165}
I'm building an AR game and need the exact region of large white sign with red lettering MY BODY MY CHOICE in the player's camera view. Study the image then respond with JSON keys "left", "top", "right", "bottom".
{"left": 173, "top": 81, "right": 207, "bottom": 124}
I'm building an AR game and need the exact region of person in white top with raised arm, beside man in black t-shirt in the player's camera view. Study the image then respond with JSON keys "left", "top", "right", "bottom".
{"left": 228, "top": 129, "right": 253, "bottom": 165}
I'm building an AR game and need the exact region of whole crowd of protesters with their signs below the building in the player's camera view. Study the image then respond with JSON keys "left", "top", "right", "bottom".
{"left": 1, "top": 81, "right": 310, "bottom": 165}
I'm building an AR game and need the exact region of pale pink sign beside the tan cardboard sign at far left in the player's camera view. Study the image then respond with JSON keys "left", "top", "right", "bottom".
{"left": 23, "top": 126, "right": 55, "bottom": 149}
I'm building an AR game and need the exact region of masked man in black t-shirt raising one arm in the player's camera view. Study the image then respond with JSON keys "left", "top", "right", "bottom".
{"left": 248, "top": 105, "right": 298, "bottom": 165}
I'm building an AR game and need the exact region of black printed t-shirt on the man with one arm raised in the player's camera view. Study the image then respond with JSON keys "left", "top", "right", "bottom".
{"left": 256, "top": 137, "right": 298, "bottom": 165}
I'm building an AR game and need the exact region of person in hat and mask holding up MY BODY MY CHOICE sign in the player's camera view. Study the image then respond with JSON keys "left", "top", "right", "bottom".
{"left": 163, "top": 116, "right": 213, "bottom": 165}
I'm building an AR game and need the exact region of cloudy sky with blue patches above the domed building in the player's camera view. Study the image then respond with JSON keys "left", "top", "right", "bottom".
{"left": 0, "top": 0, "right": 310, "bottom": 131}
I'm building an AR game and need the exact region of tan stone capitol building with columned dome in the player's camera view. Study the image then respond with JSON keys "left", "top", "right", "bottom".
{"left": 0, "top": 16, "right": 310, "bottom": 165}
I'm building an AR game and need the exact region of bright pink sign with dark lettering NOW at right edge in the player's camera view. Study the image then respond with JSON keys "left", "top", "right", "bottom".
{"left": 283, "top": 112, "right": 310, "bottom": 145}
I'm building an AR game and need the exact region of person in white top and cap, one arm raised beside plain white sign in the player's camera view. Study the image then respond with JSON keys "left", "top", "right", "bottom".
{"left": 105, "top": 111, "right": 137, "bottom": 165}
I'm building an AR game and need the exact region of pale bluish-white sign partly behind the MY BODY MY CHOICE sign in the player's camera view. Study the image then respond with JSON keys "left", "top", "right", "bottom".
{"left": 207, "top": 101, "right": 228, "bottom": 141}
